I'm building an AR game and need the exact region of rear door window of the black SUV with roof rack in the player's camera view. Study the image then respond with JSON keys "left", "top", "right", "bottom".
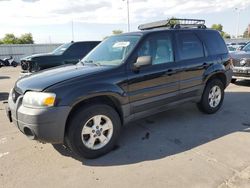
{"left": 177, "top": 33, "right": 204, "bottom": 60}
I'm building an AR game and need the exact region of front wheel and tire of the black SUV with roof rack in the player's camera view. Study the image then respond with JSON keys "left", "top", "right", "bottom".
{"left": 65, "top": 104, "right": 121, "bottom": 159}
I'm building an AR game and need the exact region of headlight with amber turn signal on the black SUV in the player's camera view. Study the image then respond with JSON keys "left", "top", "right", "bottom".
{"left": 23, "top": 91, "right": 56, "bottom": 108}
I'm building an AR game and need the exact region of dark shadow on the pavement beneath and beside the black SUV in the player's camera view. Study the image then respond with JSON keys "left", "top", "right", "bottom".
{"left": 52, "top": 91, "right": 250, "bottom": 166}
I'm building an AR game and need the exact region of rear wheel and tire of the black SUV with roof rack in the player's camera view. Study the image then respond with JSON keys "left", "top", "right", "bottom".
{"left": 197, "top": 79, "right": 224, "bottom": 114}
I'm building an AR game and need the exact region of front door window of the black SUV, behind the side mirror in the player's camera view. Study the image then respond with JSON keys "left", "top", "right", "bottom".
{"left": 137, "top": 33, "right": 174, "bottom": 65}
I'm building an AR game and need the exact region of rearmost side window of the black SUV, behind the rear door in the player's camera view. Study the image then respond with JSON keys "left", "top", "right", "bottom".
{"left": 200, "top": 31, "right": 228, "bottom": 55}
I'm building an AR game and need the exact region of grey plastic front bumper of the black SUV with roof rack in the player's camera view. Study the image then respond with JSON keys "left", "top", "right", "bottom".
{"left": 6, "top": 92, "right": 70, "bottom": 143}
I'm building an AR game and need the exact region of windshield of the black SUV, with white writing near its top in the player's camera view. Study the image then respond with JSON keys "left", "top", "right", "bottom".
{"left": 81, "top": 35, "right": 140, "bottom": 66}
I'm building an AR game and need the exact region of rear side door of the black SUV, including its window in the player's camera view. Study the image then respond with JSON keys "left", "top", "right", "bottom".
{"left": 175, "top": 31, "right": 208, "bottom": 99}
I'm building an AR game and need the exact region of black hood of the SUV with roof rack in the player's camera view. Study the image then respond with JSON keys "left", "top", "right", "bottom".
{"left": 15, "top": 64, "right": 108, "bottom": 94}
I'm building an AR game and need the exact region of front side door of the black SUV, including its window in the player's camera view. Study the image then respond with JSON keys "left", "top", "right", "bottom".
{"left": 128, "top": 32, "right": 179, "bottom": 114}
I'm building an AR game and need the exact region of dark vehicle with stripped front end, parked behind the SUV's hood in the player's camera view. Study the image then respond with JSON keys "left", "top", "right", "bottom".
{"left": 21, "top": 41, "right": 100, "bottom": 73}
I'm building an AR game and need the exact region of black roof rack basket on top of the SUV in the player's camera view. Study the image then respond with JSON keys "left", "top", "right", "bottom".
{"left": 138, "top": 18, "right": 206, "bottom": 30}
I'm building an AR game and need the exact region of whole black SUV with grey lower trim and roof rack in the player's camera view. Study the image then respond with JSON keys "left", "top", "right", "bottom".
{"left": 6, "top": 19, "right": 232, "bottom": 158}
